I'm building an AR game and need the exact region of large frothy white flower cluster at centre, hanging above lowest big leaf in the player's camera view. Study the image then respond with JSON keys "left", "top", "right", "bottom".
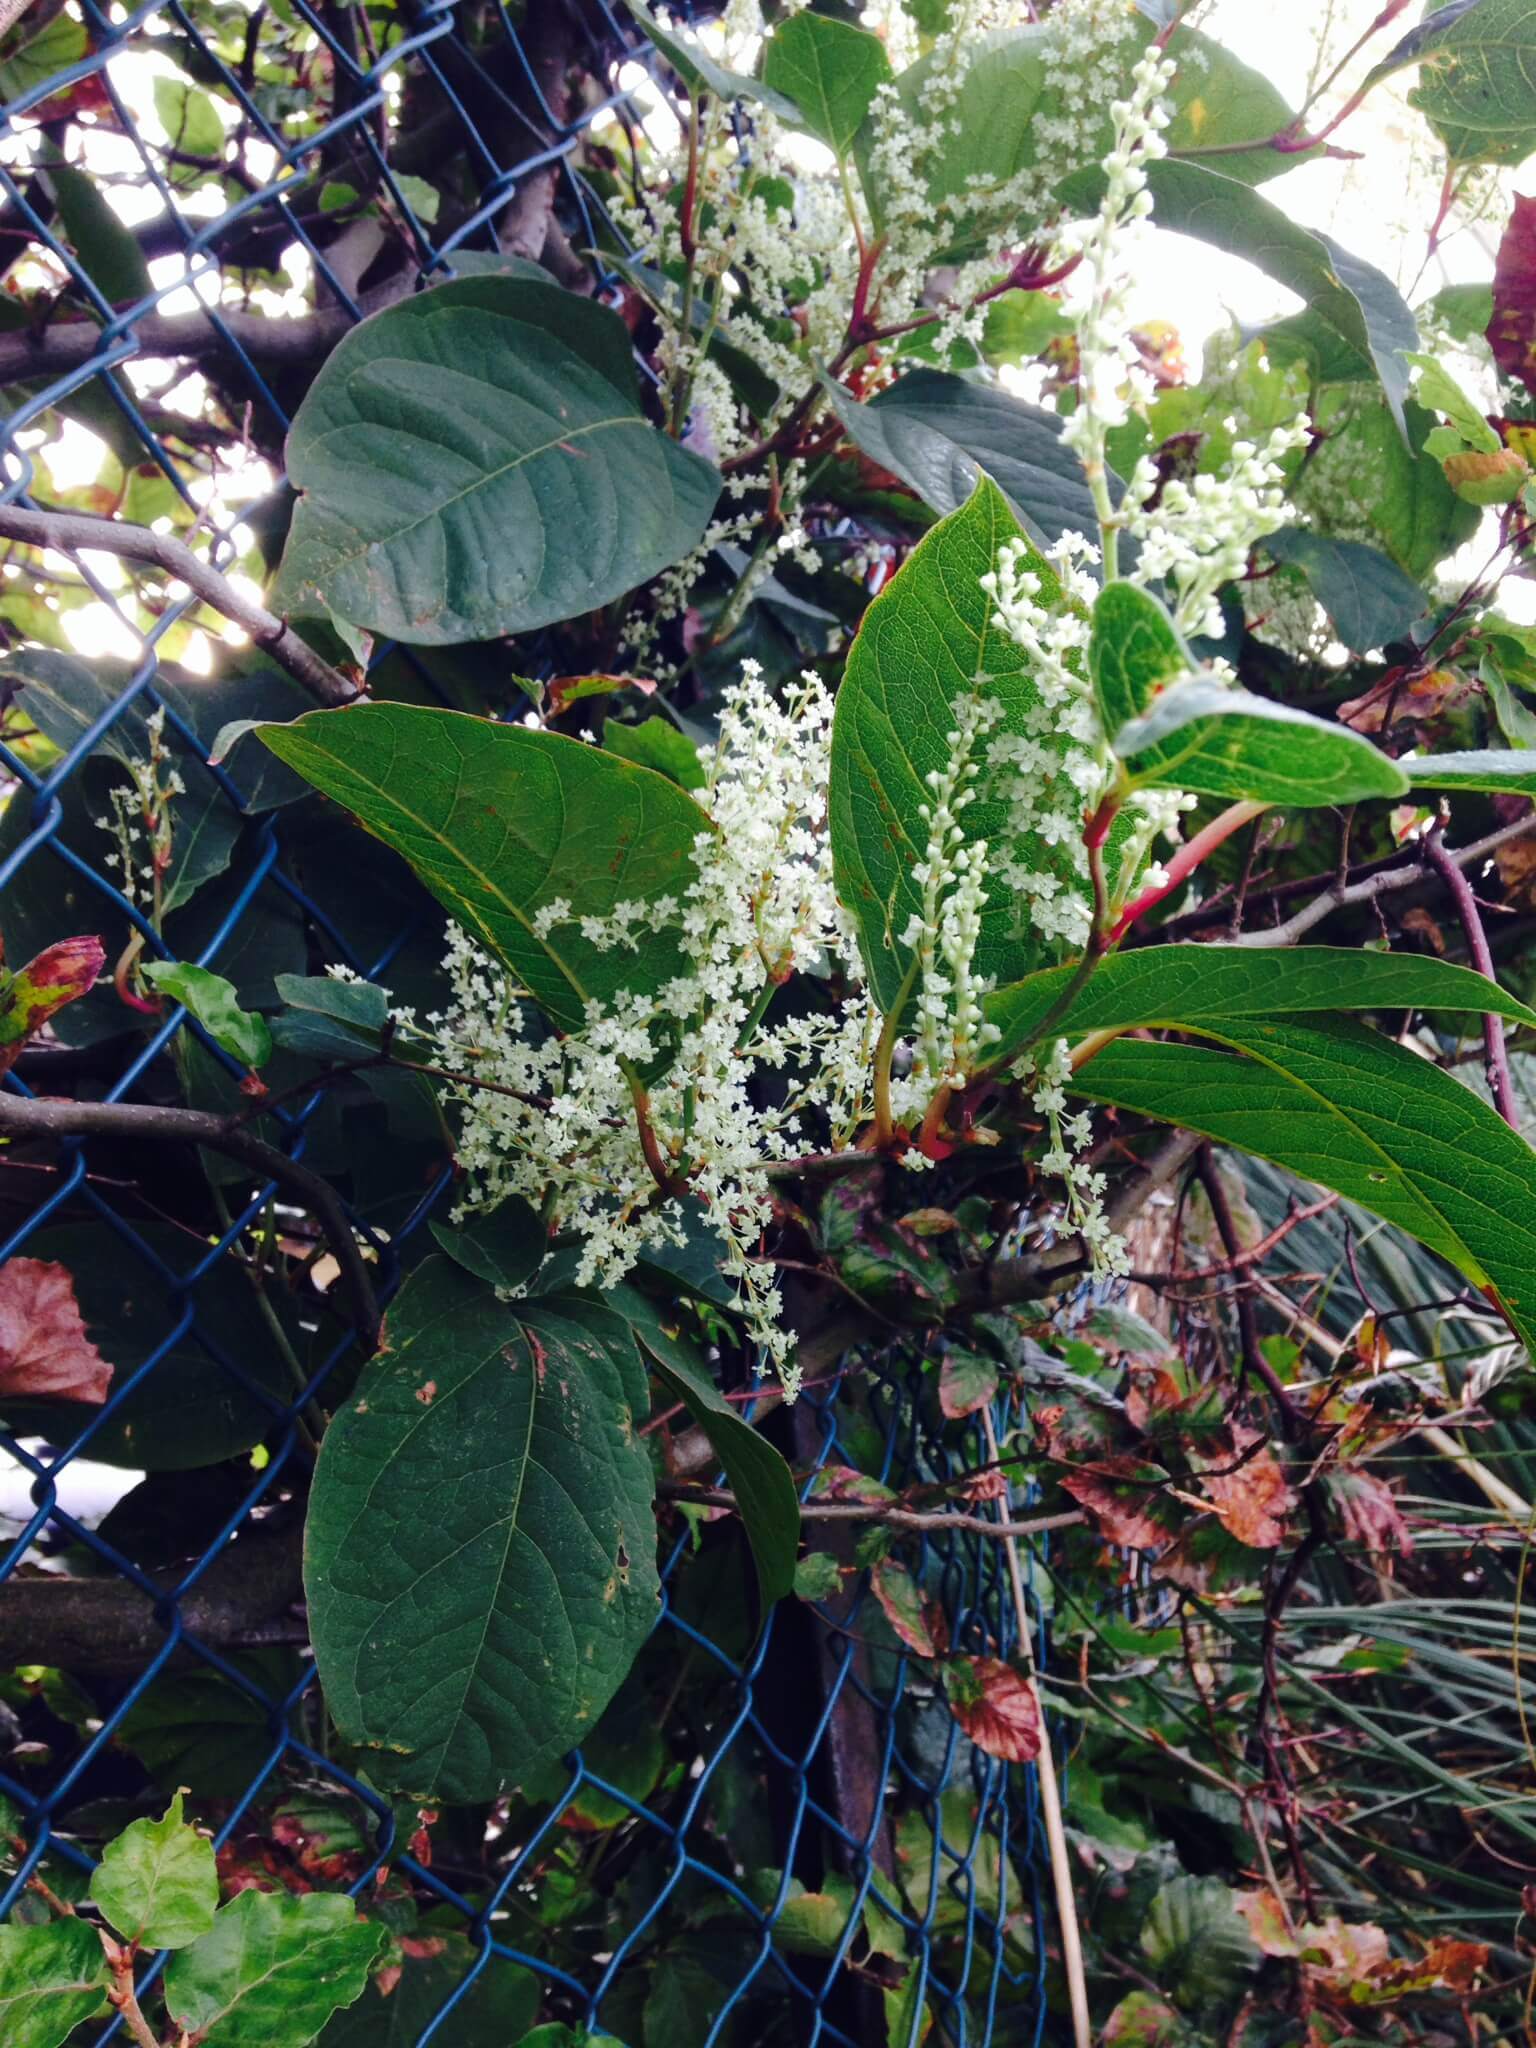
{"left": 406, "top": 664, "right": 879, "bottom": 1395}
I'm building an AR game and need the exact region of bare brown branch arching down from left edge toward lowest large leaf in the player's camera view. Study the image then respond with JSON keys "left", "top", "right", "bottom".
{"left": 0, "top": 1096, "right": 379, "bottom": 1351}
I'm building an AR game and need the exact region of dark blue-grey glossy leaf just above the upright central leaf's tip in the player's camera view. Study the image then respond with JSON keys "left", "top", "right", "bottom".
{"left": 823, "top": 372, "right": 1098, "bottom": 547}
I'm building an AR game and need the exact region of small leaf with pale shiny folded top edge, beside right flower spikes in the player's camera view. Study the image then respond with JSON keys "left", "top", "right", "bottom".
{"left": 1112, "top": 678, "right": 1409, "bottom": 809}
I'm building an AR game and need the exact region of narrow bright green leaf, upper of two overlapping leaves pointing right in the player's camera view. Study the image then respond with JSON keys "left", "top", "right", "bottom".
{"left": 985, "top": 946, "right": 1536, "bottom": 1061}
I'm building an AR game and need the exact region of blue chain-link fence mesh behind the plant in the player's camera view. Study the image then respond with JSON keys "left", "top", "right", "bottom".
{"left": 0, "top": 0, "right": 1047, "bottom": 2048}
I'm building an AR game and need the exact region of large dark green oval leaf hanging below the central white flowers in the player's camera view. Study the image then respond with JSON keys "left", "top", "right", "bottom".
{"left": 305, "top": 1257, "right": 657, "bottom": 1804}
